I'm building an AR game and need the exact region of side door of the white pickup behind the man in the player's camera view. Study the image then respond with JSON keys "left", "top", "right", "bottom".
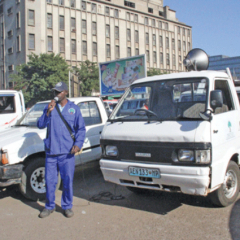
{"left": 76, "top": 101, "right": 105, "bottom": 165}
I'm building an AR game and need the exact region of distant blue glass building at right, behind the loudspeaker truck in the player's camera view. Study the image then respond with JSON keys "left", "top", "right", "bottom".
{"left": 208, "top": 55, "right": 240, "bottom": 80}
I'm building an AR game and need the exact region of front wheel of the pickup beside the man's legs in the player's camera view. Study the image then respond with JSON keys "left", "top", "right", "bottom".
{"left": 20, "top": 157, "right": 61, "bottom": 201}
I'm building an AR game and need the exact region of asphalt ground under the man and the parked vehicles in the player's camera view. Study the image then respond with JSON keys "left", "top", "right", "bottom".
{"left": 0, "top": 163, "right": 240, "bottom": 240}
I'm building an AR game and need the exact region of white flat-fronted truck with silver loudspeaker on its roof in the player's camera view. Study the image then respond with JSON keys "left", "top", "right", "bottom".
{"left": 100, "top": 49, "right": 240, "bottom": 206}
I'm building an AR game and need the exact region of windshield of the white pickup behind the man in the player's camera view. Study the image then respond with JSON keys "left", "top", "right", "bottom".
{"left": 16, "top": 103, "right": 48, "bottom": 127}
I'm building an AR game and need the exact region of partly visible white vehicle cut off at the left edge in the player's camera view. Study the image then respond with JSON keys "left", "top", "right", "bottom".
{"left": 0, "top": 90, "right": 25, "bottom": 131}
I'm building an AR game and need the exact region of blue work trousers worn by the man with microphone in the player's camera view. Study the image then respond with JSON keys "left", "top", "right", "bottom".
{"left": 45, "top": 154, "right": 75, "bottom": 210}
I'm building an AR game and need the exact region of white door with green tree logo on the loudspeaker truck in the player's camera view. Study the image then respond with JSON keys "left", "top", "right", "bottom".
{"left": 211, "top": 80, "right": 239, "bottom": 188}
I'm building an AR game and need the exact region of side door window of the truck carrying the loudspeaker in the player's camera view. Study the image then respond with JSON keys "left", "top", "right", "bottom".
{"left": 215, "top": 80, "right": 234, "bottom": 114}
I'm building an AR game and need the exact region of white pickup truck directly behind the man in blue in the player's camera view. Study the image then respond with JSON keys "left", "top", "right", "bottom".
{"left": 0, "top": 97, "right": 108, "bottom": 200}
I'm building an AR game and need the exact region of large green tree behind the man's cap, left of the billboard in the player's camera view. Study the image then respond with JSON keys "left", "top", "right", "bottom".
{"left": 10, "top": 53, "right": 69, "bottom": 106}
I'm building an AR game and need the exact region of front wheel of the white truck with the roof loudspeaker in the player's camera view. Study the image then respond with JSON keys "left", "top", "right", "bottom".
{"left": 210, "top": 161, "right": 240, "bottom": 207}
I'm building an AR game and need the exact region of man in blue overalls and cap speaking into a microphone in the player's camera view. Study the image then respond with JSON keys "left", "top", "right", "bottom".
{"left": 37, "top": 82, "right": 86, "bottom": 218}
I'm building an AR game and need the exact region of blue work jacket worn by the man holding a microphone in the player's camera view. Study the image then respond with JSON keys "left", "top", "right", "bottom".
{"left": 37, "top": 100, "right": 86, "bottom": 155}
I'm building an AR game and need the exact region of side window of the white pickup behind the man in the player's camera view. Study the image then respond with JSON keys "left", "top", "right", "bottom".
{"left": 78, "top": 101, "right": 102, "bottom": 126}
